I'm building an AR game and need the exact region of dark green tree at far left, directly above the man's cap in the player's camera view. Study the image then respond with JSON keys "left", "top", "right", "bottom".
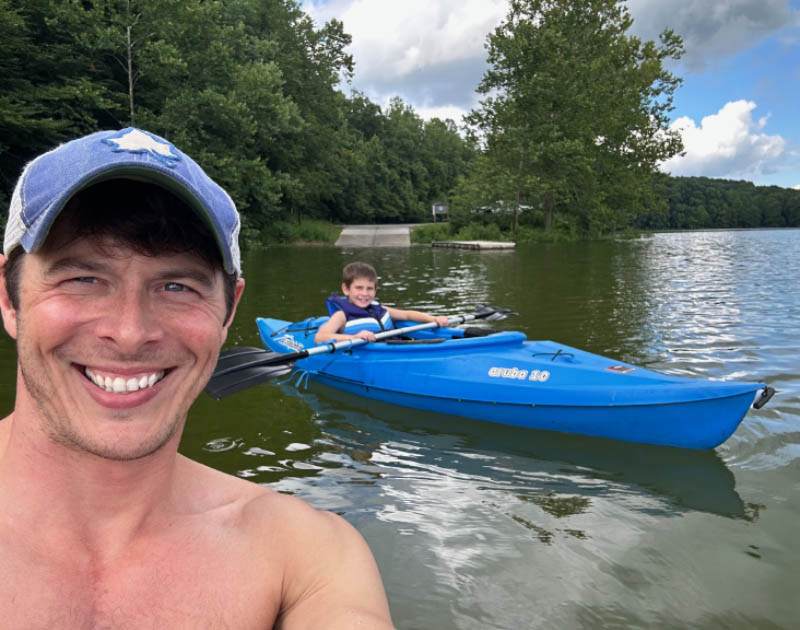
{"left": 0, "top": 0, "right": 124, "bottom": 216}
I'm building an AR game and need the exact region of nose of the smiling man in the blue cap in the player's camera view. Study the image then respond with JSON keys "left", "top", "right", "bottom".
{"left": 97, "top": 291, "right": 164, "bottom": 353}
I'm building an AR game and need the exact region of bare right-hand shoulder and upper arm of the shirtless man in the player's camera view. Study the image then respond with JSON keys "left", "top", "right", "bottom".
{"left": 175, "top": 460, "right": 392, "bottom": 630}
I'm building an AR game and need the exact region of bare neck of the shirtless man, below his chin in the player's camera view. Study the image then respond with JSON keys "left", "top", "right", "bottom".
{"left": 0, "top": 412, "right": 179, "bottom": 557}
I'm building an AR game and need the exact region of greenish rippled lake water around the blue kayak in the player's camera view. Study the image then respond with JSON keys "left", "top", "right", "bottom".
{"left": 0, "top": 230, "right": 800, "bottom": 630}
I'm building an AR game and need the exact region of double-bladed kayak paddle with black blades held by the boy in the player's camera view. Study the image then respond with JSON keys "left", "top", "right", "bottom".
{"left": 206, "top": 306, "right": 511, "bottom": 400}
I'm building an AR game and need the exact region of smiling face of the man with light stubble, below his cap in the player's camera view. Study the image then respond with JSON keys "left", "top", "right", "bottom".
{"left": 0, "top": 234, "right": 244, "bottom": 460}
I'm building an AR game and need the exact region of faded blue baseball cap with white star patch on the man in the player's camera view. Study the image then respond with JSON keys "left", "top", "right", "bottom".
{"left": 3, "top": 127, "right": 241, "bottom": 276}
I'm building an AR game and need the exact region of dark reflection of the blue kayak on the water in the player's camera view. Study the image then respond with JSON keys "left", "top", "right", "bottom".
{"left": 302, "top": 385, "right": 748, "bottom": 518}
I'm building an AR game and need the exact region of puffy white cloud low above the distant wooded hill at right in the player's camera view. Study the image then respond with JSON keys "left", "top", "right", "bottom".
{"left": 662, "top": 100, "right": 787, "bottom": 179}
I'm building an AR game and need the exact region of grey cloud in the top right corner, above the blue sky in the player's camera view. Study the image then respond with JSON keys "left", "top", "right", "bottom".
{"left": 628, "top": 0, "right": 800, "bottom": 70}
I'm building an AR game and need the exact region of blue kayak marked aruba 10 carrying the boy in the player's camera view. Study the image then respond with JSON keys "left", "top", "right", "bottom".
{"left": 256, "top": 317, "right": 773, "bottom": 449}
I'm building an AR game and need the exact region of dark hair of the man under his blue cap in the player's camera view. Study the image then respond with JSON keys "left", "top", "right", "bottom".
{"left": 5, "top": 179, "right": 241, "bottom": 322}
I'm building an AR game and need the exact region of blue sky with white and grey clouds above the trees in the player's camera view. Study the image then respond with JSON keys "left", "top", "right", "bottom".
{"left": 303, "top": 0, "right": 800, "bottom": 189}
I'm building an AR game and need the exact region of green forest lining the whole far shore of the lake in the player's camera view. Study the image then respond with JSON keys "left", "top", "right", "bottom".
{"left": 0, "top": 0, "right": 800, "bottom": 243}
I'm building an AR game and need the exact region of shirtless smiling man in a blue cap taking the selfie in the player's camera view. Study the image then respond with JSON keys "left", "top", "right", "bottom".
{"left": 0, "top": 128, "right": 391, "bottom": 630}
